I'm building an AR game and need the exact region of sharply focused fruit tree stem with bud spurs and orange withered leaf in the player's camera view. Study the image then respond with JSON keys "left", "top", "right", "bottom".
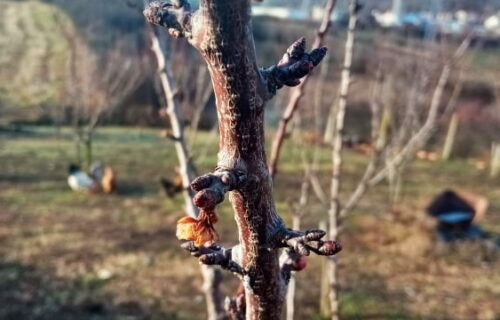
{"left": 144, "top": 0, "right": 341, "bottom": 319}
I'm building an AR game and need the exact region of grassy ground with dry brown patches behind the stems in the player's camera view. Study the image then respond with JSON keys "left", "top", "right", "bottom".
{"left": 0, "top": 127, "right": 500, "bottom": 319}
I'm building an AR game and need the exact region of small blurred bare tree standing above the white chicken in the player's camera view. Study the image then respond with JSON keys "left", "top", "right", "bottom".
{"left": 67, "top": 34, "right": 145, "bottom": 169}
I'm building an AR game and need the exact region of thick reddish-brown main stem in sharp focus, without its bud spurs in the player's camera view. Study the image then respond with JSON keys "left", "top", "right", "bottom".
{"left": 195, "top": 0, "right": 285, "bottom": 320}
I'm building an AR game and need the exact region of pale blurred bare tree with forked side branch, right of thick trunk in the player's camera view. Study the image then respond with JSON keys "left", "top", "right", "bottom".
{"left": 319, "top": 18, "right": 469, "bottom": 319}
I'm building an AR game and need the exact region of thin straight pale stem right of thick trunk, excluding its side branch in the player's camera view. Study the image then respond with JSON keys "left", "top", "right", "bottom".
{"left": 328, "top": 0, "right": 358, "bottom": 320}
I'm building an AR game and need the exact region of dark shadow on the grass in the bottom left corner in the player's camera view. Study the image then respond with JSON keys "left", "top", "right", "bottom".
{"left": 0, "top": 258, "right": 178, "bottom": 320}
